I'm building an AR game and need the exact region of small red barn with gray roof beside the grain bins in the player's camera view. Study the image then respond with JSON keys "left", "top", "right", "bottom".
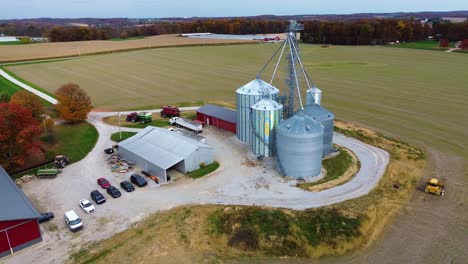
{"left": 197, "top": 104, "right": 237, "bottom": 134}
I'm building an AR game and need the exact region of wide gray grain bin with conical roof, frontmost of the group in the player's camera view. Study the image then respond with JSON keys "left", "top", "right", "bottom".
{"left": 276, "top": 111, "right": 324, "bottom": 179}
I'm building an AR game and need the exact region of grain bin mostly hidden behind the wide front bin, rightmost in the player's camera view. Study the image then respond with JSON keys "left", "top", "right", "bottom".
{"left": 304, "top": 103, "right": 335, "bottom": 157}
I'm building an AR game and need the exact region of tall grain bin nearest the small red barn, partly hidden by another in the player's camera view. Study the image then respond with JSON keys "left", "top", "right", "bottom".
{"left": 236, "top": 79, "right": 279, "bottom": 145}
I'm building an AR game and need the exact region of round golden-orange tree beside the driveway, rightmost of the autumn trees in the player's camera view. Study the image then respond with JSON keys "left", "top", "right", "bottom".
{"left": 55, "top": 83, "right": 93, "bottom": 123}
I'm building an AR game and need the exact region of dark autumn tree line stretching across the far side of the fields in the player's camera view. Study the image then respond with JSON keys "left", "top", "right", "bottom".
{"left": 0, "top": 18, "right": 468, "bottom": 42}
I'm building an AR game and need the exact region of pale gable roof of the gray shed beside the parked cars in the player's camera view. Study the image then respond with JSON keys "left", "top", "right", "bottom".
{"left": 119, "top": 126, "right": 212, "bottom": 170}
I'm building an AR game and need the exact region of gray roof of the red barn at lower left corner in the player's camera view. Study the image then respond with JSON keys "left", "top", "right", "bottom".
{"left": 0, "top": 166, "right": 41, "bottom": 221}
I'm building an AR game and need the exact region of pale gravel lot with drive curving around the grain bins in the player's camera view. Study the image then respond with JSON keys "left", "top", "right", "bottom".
{"left": 2, "top": 111, "right": 389, "bottom": 263}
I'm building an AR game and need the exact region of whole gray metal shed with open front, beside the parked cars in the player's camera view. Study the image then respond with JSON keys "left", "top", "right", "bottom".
{"left": 119, "top": 126, "right": 214, "bottom": 182}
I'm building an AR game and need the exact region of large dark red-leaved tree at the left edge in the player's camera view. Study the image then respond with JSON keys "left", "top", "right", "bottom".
{"left": 0, "top": 103, "right": 44, "bottom": 170}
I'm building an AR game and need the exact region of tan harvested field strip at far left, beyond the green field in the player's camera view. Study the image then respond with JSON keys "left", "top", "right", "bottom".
{"left": 0, "top": 35, "right": 255, "bottom": 62}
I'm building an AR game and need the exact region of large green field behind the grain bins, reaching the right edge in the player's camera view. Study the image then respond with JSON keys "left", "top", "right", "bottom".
{"left": 6, "top": 45, "right": 468, "bottom": 156}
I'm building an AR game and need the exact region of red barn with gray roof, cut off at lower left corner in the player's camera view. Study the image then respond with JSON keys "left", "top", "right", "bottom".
{"left": 0, "top": 166, "right": 42, "bottom": 257}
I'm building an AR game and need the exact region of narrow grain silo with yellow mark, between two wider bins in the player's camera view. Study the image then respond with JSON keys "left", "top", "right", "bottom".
{"left": 251, "top": 99, "right": 283, "bottom": 157}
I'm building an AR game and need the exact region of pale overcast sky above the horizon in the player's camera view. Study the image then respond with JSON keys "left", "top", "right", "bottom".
{"left": 0, "top": 0, "right": 468, "bottom": 19}
